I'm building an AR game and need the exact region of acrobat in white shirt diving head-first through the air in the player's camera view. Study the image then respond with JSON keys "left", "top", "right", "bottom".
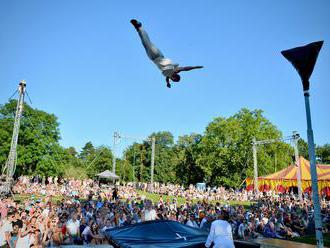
{"left": 131, "top": 19, "right": 203, "bottom": 88}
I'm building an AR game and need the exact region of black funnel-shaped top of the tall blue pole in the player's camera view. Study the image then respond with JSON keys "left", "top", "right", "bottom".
{"left": 281, "top": 41, "right": 323, "bottom": 91}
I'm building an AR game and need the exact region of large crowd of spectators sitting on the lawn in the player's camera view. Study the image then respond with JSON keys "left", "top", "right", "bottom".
{"left": 0, "top": 176, "right": 330, "bottom": 248}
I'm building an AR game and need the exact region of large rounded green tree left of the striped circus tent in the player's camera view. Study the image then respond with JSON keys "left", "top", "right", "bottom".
{"left": 197, "top": 109, "right": 292, "bottom": 187}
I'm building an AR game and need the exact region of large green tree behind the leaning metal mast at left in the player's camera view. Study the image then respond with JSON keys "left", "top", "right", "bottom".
{"left": 0, "top": 100, "right": 63, "bottom": 175}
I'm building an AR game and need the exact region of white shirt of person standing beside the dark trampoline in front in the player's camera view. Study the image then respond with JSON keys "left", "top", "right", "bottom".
{"left": 205, "top": 220, "right": 235, "bottom": 248}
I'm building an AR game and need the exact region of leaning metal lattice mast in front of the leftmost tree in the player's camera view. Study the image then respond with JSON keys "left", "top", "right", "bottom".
{"left": 0, "top": 80, "right": 26, "bottom": 194}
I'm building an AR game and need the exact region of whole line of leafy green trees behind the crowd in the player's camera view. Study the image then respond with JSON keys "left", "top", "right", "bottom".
{"left": 0, "top": 100, "right": 324, "bottom": 187}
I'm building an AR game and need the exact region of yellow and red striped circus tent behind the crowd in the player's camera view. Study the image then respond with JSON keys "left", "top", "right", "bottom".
{"left": 246, "top": 157, "right": 330, "bottom": 192}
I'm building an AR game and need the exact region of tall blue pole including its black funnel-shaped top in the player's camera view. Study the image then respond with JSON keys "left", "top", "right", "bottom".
{"left": 281, "top": 41, "right": 323, "bottom": 247}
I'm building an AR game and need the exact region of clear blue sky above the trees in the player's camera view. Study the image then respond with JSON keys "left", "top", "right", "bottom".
{"left": 0, "top": 0, "right": 330, "bottom": 154}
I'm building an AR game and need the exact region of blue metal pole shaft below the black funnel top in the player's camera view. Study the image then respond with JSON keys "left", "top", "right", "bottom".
{"left": 304, "top": 90, "right": 324, "bottom": 247}
